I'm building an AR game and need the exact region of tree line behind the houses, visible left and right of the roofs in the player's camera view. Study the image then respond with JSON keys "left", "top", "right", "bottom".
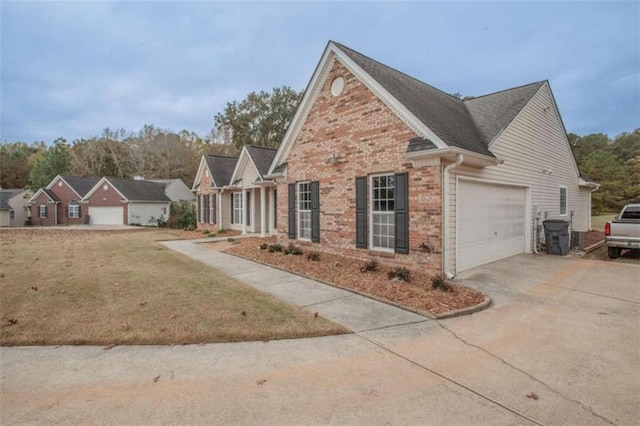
{"left": 0, "top": 86, "right": 640, "bottom": 214}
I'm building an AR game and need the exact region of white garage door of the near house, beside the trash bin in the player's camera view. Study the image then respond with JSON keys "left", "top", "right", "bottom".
{"left": 456, "top": 180, "right": 527, "bottom": 272}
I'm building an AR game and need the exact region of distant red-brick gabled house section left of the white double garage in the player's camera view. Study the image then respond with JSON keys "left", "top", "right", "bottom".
{"left": 29, "top": 175, "right": 98, "bottom": 226}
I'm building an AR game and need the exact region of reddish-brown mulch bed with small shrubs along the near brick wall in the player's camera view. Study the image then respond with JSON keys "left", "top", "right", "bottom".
{"left": 208, "top": 238, "right": 485, "bottom": 315}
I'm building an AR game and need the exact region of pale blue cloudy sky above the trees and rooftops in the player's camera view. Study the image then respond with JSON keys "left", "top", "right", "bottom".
{"left": 0, "top": 0, "right": 640, "bottom": 143}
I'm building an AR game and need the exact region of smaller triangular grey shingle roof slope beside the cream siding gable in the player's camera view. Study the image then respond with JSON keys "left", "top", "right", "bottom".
{"left": 464, "top": 81, "right": 546, "bottom": 146}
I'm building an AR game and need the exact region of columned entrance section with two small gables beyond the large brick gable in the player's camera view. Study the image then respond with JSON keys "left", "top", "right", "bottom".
{"left": 193, "top": 145, "right": 277, "bottom": 236}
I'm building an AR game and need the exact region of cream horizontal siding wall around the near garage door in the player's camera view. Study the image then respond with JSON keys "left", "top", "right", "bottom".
{"left": 448, "top": 85, "right": 589, "bottom": 271}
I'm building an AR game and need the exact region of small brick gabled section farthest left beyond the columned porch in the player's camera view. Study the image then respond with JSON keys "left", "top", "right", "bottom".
{"left": 192, "top": 155, "right": 238, "bottom": 230}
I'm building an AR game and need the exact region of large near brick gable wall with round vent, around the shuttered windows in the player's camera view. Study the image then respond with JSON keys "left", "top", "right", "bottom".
{"left": 277, "top": 61, "right": 442, "bottom": 274}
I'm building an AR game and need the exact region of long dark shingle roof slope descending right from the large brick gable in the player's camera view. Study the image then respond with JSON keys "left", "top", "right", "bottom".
{"left": 334, "top": 42, "right": 493, "bottom": 156}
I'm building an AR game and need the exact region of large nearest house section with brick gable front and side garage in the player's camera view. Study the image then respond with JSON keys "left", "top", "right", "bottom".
{"left": 263, "top": 42, "right": 595, "bottom": 275}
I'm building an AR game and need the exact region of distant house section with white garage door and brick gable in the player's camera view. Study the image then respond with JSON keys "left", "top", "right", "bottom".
{"left": 83, "top": 177, "right": 171, "bottom": 225}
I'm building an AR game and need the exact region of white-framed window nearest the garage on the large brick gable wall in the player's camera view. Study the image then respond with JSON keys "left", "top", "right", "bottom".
{"left": 369, "top": 174, "right": 395, "bottom": 250}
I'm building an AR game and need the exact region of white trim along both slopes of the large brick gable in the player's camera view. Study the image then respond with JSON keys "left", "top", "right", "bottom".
{"left": 267, "top": 42, "right": 448, "bottom": 175}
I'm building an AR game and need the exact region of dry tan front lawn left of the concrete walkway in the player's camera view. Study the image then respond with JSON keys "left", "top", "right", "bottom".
{"left": 0, "top": 228, "right": 347, "bottom": 345}
